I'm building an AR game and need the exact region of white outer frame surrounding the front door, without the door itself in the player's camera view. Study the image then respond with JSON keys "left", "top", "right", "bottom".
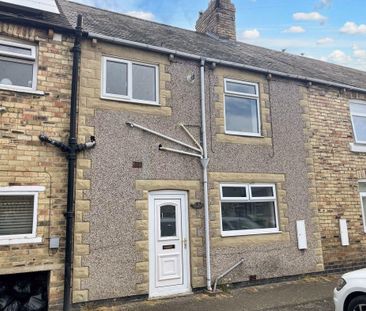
{"left": 148, "top": 190, "right": 192, "bottom": 299}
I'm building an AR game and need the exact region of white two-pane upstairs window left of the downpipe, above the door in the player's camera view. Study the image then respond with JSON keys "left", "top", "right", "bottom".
{"left": 102, "top": 57, "right": 159, "bottom": 105}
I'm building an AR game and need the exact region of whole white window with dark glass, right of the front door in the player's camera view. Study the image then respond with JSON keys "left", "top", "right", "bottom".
{"left": 220, "top": 184, "right": 279, "bottom": 236}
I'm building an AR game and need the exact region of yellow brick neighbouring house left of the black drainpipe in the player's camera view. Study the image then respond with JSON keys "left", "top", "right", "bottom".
{"left": 0, "top": 0, "right": 74, "bottom": 310}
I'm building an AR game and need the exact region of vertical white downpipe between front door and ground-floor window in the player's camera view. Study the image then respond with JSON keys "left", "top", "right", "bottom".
{"left": 200, "top": 59, "right": 212, "bottom": 291}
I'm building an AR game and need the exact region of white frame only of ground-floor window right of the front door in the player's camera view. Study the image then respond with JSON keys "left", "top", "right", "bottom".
{"left": 220, "top": 183, "right": 281, "bottom": 237}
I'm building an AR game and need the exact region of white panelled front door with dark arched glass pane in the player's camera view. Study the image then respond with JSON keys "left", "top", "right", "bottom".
{"left": 149, "top": 191, "right": 191, "bottom": 298}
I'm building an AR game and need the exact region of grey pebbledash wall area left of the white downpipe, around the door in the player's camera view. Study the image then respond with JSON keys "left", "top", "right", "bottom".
{"left": 84, "top": 61, "right": 201, "bottom": 300}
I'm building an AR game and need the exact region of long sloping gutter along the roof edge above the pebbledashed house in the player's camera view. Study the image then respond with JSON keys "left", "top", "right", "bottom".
{"left": 88, "top": 32, "right": 366, "bottom": 93}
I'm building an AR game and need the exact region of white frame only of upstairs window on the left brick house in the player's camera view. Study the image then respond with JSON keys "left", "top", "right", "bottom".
{"left": 0, "top": 39, "right": 38, "bottom": 92}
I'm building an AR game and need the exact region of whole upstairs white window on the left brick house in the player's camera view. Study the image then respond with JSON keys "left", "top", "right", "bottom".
{"left": 0, "top": 39, "right": 37, "bottom": 91}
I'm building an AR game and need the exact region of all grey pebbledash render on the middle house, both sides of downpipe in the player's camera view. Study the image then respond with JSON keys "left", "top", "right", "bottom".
{"left": 82, "top": 54, "right": 316, "bottom": 300}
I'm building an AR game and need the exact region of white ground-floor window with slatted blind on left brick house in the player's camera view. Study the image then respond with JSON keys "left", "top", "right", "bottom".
{"left": 0, "top": 186, "right": 44, "bottom": 245}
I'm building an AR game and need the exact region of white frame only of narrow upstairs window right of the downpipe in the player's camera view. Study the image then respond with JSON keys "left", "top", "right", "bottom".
{"left": 224, "top": 78, "right": 262, "bottom": 137}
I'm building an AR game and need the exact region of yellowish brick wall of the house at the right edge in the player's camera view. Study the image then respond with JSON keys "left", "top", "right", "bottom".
{"left": 307, "top": 87, "right": 366, "bottom": 269}
